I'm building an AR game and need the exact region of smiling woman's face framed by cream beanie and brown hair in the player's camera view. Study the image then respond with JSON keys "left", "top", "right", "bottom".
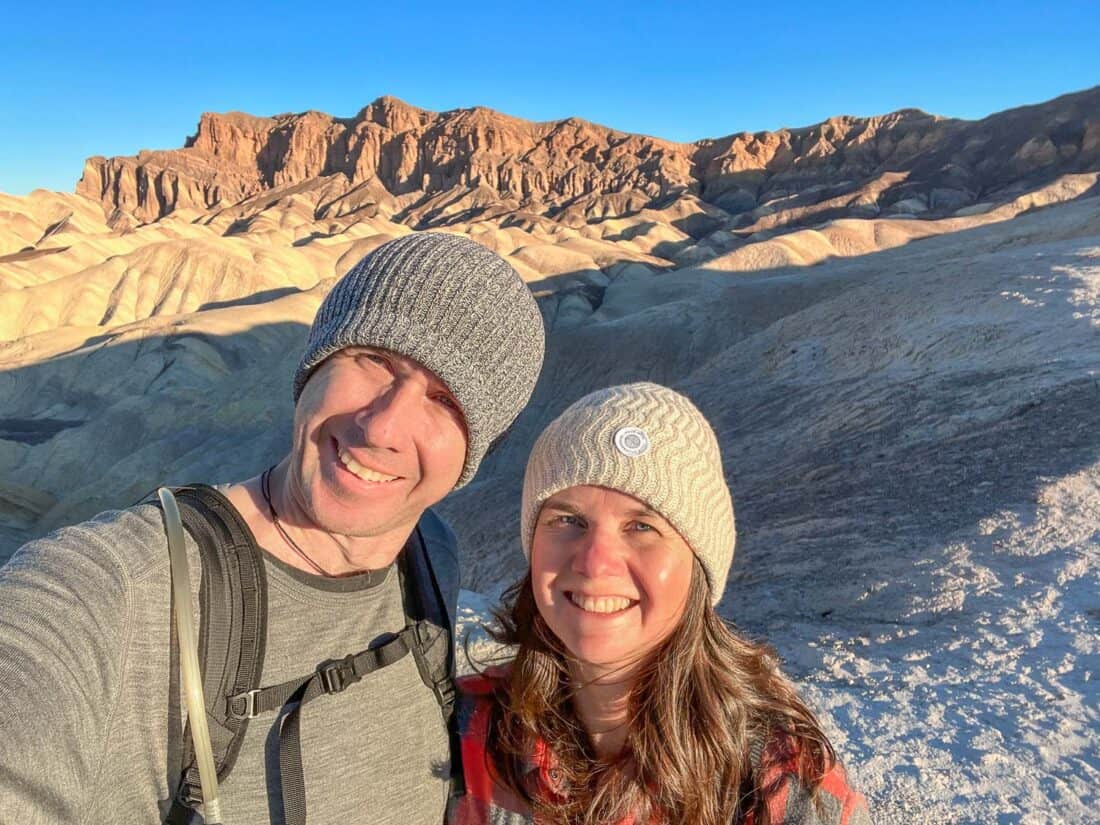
{"left": 531, "top": 486, "right": 694, "bottom": 678}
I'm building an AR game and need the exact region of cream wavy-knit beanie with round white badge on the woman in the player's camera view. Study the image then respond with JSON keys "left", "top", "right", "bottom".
{"left": 520, "top": 382, "right": 736, "bottom": 604}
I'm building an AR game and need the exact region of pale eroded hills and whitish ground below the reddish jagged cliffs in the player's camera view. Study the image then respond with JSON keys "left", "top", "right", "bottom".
{"left": 0, "top": 174, "right": 1100, "bottom": 823}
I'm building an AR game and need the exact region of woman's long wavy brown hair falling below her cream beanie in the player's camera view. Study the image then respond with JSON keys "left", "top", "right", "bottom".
{"left": 487, "top": 563, "right": 836, "bottom": 825}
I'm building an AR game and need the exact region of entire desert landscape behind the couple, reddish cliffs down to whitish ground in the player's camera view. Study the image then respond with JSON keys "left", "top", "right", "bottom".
{"left": 0, "top": 88, "right": 1100, "bottom": 823}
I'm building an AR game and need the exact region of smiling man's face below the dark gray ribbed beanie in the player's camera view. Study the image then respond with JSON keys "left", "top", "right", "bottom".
{"left": 288, "top": 347, "right": 466, "bottom": 541}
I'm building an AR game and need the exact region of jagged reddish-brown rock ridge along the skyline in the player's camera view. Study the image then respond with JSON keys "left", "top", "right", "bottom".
{"left": 78, "top": 89, "right": 1100, "bottom": 228}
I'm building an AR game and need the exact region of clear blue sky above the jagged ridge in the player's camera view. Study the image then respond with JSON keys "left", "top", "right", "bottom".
{"left": 0, "top": 0, "right": 1100, "bottom": 195}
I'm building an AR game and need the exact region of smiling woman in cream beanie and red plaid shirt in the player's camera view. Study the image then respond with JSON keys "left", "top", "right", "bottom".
{"left": 450, "top": 383, "right": 869, "bottom": 825}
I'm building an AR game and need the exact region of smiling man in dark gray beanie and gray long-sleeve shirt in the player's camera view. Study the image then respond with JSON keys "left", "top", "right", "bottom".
{"left": 0, "top": 233, "right": 543, "bottom": 825}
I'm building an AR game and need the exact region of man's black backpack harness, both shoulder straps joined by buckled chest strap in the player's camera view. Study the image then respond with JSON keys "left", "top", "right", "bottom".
{"left": 156, "top": 485, "right": 462, "bottom": 825}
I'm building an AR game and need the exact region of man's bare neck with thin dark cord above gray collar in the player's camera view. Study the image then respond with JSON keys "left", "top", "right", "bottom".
{"left": 226, "top": 461, "right": 408, "bottom": 576}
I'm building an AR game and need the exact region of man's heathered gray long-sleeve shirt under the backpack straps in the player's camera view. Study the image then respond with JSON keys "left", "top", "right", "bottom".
{"left": 0, "top": 505, "right": 449, "bottom": 825}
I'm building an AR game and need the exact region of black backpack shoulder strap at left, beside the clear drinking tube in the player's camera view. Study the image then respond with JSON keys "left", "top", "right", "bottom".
{"left": 155, "top": 485, "right": 267, "bottom": 823}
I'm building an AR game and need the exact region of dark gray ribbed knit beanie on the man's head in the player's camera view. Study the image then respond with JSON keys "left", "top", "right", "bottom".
{"left": 294, "top": 232, "right": 545, "bottom": 488}
